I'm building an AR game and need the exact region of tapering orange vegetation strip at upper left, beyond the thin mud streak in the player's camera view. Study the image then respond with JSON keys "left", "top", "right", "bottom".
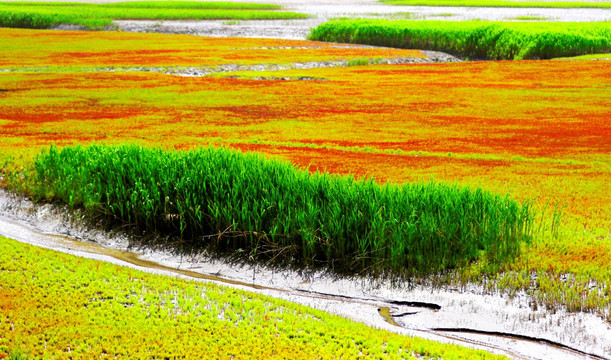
{"left": 0, "top": 29, "right": 425, "bottom": 67}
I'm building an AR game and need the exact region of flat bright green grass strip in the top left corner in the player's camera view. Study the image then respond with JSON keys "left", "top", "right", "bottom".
{"left": 0, "top": 1, "right": 307, "bottom": 29}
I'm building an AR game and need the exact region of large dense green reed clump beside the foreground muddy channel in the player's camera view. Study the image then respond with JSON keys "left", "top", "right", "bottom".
{"left": 21, "top": 145, "right": 532, "bottom": 275}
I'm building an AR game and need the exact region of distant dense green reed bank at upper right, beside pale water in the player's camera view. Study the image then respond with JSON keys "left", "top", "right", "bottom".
{"left": 309, "top": 19, "right": 611, "bottom": 60}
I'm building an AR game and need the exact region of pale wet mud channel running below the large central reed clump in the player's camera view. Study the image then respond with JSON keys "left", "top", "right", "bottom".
{"left": 0, "top": 190, "right": 611, "bottom": 359}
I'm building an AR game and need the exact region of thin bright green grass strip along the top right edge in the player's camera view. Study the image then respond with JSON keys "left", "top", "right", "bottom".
{"left": 380, "top": 0, "right": 611, "bottom": 9}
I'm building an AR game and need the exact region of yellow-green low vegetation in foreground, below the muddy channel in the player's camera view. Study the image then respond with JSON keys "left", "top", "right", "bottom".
{"left": 0, "top": 237, "right": 501, "bottom": 359}
